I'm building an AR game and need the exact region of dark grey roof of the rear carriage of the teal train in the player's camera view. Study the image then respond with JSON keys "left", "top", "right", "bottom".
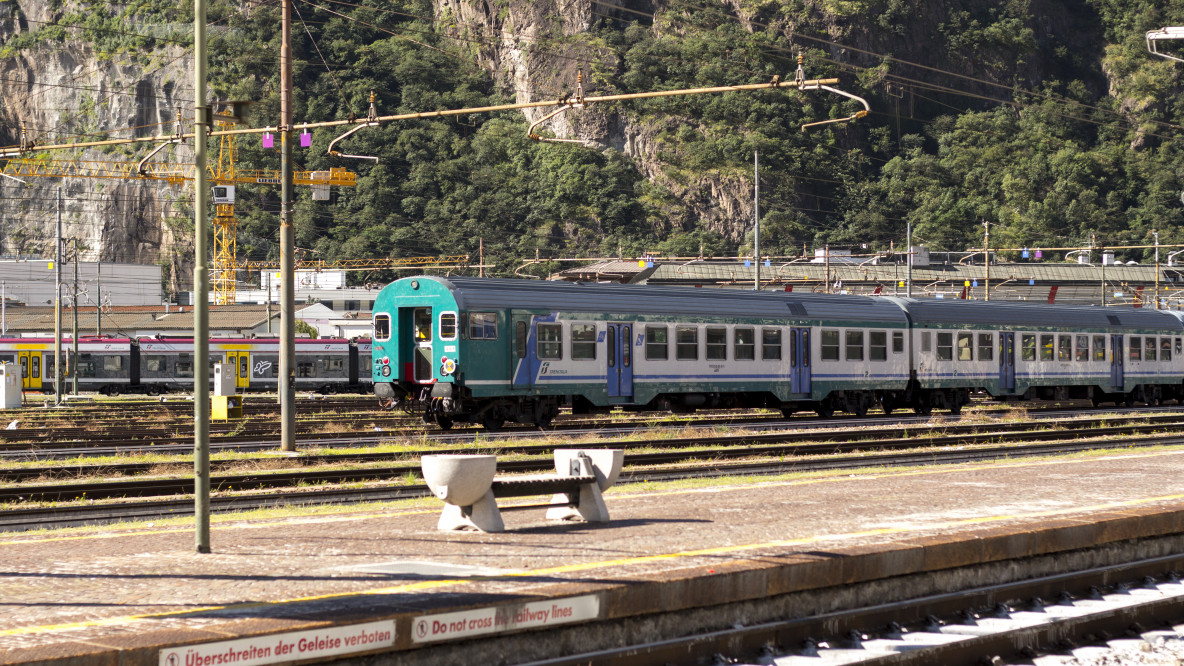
{"left": 888, "top": 297, "right": 1184, "bottom": 331}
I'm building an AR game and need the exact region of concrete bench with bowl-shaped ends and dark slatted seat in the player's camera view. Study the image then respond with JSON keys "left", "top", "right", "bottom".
{"left": 419, "top": 449, "right": 625, "bottom": 532}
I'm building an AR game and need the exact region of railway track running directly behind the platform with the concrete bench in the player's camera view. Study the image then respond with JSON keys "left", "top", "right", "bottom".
{"left": 0, "top": 424, "right": 1184, "bottom": 531}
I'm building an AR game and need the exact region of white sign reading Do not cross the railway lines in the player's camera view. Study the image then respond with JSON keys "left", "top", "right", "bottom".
{"left": 411, "top": 595, "right": 600, "bottom": 642}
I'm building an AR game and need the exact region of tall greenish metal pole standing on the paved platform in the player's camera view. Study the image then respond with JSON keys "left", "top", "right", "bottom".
{"left": 192, "top": 0, "right": 210, "bottom": 552}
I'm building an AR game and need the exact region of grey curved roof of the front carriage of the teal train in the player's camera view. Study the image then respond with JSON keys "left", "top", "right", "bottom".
{"left": 387, "top": 276, "right": 907, "bottom": 326}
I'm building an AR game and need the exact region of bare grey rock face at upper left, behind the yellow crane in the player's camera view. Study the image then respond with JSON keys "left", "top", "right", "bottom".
{"left": 0, "top": 0, "right": 193, "bottom": 298}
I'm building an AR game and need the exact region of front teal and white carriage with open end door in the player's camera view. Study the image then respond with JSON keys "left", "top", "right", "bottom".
{"left": 373, "top": 276, "right": 909, "bottom": 428}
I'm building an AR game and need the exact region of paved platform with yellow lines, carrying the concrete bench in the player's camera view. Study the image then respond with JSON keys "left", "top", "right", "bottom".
{"left": 0, "top": 449, "right": 1184, "bottom": 666}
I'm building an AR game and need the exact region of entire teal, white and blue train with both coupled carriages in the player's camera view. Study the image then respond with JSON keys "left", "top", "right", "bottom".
{"left": 372, "top": 276, "right": 1184, "bottom": 429}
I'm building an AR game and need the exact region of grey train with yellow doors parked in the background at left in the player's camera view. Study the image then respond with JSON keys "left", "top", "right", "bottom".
{"left": 0, "top": 338, "right": 371, "bottom": 395}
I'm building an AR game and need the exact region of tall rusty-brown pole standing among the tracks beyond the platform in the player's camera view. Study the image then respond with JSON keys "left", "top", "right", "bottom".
{"left": 279, "top": 0, "right": 296, "bottom": 452}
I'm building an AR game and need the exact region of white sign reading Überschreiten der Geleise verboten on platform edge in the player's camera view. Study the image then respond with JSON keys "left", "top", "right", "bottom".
{"left": 160, "top": 620, "right": 394, "bottom": 666}
